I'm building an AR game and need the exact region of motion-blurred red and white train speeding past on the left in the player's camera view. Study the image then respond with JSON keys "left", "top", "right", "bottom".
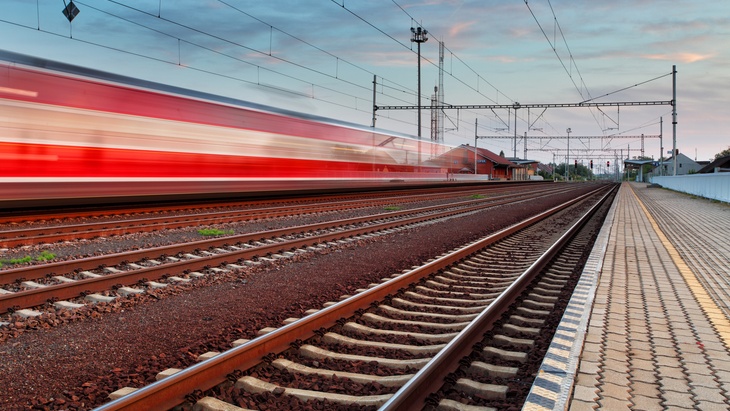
{"left": 0, "top": 51, "right": 446, "bottom": 208}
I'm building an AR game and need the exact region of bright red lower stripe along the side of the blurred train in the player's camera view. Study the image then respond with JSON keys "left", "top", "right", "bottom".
{"left": 0, "top": 143, "right": 414, "bottom": 178}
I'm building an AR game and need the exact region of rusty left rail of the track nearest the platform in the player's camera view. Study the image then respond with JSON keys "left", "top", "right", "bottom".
{"left": 89, "top": 187, "right": 605, "bottom": 411}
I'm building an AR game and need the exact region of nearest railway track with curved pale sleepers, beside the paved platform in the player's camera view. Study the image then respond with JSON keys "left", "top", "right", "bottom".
{"left": 88, "top": 184, "right": 611, "bottom": 411}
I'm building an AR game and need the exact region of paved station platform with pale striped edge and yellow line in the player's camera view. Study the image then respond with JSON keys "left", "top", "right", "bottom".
{"left": 523, "top": 183, "right": 730, "bottom": 411}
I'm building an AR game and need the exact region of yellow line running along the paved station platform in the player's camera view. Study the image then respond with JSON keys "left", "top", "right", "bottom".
{"left": 627, "top": 184, "right": 730, "bottom": 349}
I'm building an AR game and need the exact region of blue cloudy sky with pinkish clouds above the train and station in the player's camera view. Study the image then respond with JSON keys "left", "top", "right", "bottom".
{"left": 0, "top": 0, "right": 730, "bottom": 164}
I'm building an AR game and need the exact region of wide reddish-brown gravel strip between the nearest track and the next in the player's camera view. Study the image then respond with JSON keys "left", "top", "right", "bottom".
{"left": 0, "top": 187, "right": 588, "bottom": 410}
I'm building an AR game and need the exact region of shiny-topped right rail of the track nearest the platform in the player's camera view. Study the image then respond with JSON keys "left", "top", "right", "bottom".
{"left": 379, "top": 187, "right": 616, "bottom": 411}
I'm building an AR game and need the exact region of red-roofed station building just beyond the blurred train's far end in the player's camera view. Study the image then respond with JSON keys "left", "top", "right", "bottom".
{"left": 435, "top": 144, "right": 516, "bottom": 180}
